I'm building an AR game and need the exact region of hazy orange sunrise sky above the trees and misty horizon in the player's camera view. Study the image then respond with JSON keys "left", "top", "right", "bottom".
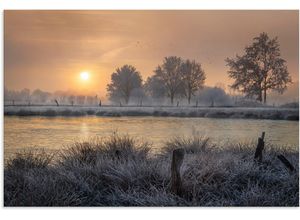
{"left": 4, "top": 10, "right": 299, "bottom": 99}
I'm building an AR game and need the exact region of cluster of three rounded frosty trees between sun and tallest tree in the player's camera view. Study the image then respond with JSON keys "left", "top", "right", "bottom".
{"left": 107, "top": 56, "right": 206, "bottom": 104}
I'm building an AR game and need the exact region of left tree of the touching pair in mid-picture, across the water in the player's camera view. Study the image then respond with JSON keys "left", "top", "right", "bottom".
{"left": 154, "top": 56, "right": 182, "bottom": 104}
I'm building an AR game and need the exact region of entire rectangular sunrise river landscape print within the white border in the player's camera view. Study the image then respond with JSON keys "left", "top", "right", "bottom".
{"left": 3, "top": 10, "right": 299, "bottom": 207}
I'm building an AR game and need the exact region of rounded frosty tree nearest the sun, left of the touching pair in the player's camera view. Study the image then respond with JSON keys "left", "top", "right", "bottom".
{"left": 107, "top": 65, "right": 142, "bottom": 104}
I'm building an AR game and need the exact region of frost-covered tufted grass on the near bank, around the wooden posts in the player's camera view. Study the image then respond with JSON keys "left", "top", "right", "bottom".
{"left": 4, "top": 136, "right": 299, "bottom": 206}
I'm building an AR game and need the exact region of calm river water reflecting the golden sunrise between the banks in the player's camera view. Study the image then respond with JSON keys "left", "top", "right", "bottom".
{"left": 4, "top": 116, "right": 299, "bottom": 156}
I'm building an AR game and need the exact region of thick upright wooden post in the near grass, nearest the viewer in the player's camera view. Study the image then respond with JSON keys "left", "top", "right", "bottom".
{"left": 171, "top": 148, "right": 184, "bottom": 196}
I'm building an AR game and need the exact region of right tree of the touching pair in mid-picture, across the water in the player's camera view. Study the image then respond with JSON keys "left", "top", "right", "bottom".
{"left": 181, "top": 60, "right": 206, "bottom": 104}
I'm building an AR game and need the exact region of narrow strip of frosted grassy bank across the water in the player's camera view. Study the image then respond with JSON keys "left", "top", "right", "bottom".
{"left": 4, "top": 106, "right": 299, "bottom": 120}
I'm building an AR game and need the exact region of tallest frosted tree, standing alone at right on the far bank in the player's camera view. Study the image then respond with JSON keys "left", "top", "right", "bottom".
{"left": 225, "top": 33, "right": 291, "bottom": 103}
